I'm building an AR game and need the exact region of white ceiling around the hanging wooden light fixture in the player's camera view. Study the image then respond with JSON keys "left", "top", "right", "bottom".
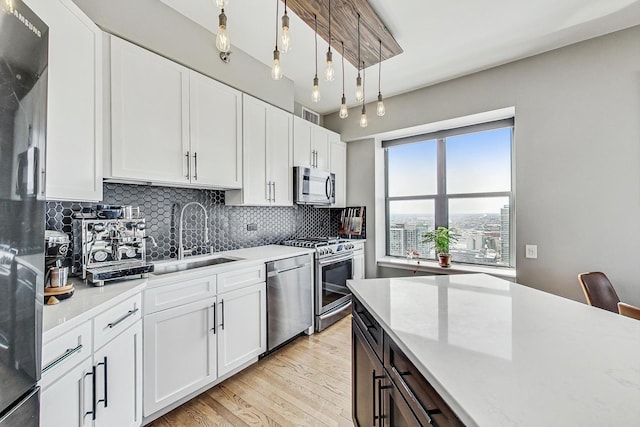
{"left": 161, "top": 0, "right": 640, "bottom": 114}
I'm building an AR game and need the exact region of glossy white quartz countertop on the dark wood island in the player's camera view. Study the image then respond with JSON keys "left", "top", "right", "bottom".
{"left": 348, "top": 274, "right": 640, "bottom": 427}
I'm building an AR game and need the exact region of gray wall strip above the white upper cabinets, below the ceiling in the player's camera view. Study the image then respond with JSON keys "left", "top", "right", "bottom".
{"left": 73, "top": 0, "right": 294, "bottom": 113}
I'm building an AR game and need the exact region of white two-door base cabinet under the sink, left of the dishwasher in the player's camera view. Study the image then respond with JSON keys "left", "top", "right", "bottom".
{"left": 143, "top": 264, "right": 267, "bottom": 422}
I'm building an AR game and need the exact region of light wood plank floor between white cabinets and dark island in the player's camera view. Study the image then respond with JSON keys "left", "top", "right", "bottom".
{"left": 149, "top": 316, "right": 353, "bottom": 427}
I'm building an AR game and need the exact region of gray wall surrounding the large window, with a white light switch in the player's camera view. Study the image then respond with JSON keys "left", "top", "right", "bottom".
{"left": 324, "top": 27, "right": 640, "bottom": 305}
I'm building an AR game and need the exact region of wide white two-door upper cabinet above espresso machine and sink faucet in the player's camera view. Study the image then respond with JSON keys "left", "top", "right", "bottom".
{"left": 105, "top": 37, "right": 242, "bottom": 188}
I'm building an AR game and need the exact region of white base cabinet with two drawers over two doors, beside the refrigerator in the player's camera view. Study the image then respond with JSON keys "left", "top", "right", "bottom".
{"left": 40, "top": 294, "right": 142, "bottom": 427}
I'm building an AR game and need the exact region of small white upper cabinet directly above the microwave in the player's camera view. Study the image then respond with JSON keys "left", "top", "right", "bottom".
{"left": 293, "top": 116, "right": 330, "bottom": 170}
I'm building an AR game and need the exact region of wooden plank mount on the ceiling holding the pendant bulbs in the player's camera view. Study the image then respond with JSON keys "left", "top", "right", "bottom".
{"left": 282, "top": 0, "right": 402, "bottom": 68}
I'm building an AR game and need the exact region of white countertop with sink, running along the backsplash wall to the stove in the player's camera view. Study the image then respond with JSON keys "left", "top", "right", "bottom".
{"left": 42, "top": 245, "right": 314, "bottom": 342}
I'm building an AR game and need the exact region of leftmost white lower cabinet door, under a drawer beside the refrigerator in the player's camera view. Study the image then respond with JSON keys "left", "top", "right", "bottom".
{"left": 40, "top": 357, "right": 93, "bottom": 427}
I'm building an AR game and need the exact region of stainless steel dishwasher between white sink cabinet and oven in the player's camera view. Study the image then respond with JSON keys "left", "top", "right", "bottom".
{"left": 267, "top": 254, "right": 313, "bottom": 351}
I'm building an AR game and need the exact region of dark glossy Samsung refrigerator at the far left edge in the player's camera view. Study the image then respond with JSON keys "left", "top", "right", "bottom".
{"left": 0, "top": 0, "right": 49, "bottom": 427}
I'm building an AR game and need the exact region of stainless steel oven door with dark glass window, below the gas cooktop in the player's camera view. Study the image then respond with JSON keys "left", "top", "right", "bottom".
{"left": 316, "top": 253, "right": 353, "bottom": 315}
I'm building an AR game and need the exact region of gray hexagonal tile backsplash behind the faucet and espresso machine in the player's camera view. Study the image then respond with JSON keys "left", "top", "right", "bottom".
{"left": 46, "top": 183, "right": 340, "bottom": 270}
